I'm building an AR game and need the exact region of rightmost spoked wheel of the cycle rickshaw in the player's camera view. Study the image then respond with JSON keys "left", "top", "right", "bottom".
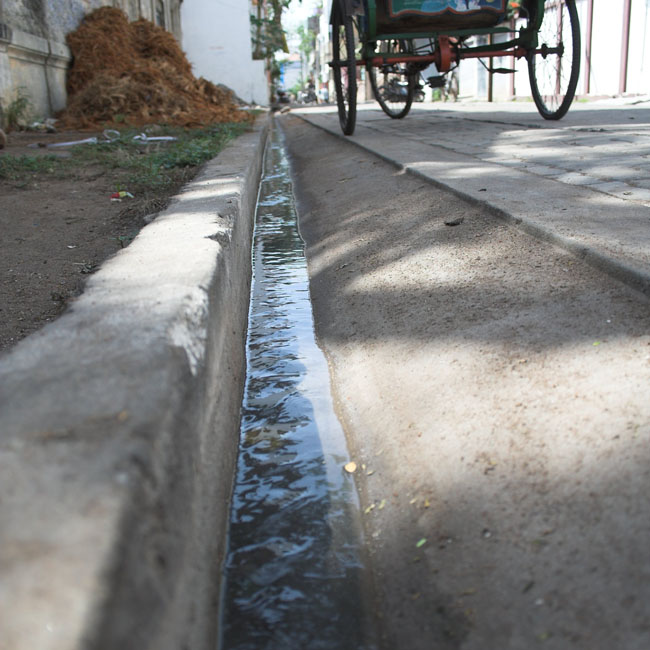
{"left": 528, "top": 0, "right": 580, "bottom": 120}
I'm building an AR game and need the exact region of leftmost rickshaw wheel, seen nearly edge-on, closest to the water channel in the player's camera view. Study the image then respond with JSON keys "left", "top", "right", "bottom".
{"left": 332, "top": 3, "right": 357, "bottom": 135}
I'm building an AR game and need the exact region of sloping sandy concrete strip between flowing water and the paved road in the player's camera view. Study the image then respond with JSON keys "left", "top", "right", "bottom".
{"left": 279, "top": 116, "right": 650, "bottom": 650}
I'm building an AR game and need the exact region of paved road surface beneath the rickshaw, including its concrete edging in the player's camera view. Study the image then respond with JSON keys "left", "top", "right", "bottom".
{"left": 293, "top": 97, "right": 650, "bottom": 295}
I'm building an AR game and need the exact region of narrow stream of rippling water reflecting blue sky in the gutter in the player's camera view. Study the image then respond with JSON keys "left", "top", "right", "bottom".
{"left": 220, "top": 129, "right": 375, "bottom": 650}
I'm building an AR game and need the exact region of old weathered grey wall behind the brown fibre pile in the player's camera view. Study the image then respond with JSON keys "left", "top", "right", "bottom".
{"left": 0, "top": 0, "right": 181, "bottom": 119}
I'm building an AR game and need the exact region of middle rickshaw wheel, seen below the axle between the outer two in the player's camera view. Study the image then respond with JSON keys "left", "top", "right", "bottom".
{"left": 367, "top": 40, "right": 417, "bottom": 120}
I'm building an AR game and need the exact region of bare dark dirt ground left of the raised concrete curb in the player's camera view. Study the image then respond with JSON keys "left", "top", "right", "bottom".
{"left": 0, "top": 131, "right": 176, "bottom": 354}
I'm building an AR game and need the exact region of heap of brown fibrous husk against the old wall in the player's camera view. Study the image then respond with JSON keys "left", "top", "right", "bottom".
{"left": 58, "top": 7, "right": 250, "bottom": 128}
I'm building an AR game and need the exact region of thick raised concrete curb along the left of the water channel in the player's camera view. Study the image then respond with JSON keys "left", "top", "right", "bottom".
{"left": 0, "top": 118, "right": 268, "bottom": 650}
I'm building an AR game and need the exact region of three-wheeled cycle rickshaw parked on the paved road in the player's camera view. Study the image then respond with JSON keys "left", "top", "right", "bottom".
{"left": 330, "top": 0, "right": 580, "bottom": 135}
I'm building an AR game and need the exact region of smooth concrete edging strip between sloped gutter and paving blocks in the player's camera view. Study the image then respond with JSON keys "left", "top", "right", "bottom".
{"left": 292, "top": 112, "right": 650, "bottom": 297}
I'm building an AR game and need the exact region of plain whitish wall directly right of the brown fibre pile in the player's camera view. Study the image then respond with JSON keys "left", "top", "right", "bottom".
{"left": 181, "top": 0, "right": 269, "bottom": 105}
